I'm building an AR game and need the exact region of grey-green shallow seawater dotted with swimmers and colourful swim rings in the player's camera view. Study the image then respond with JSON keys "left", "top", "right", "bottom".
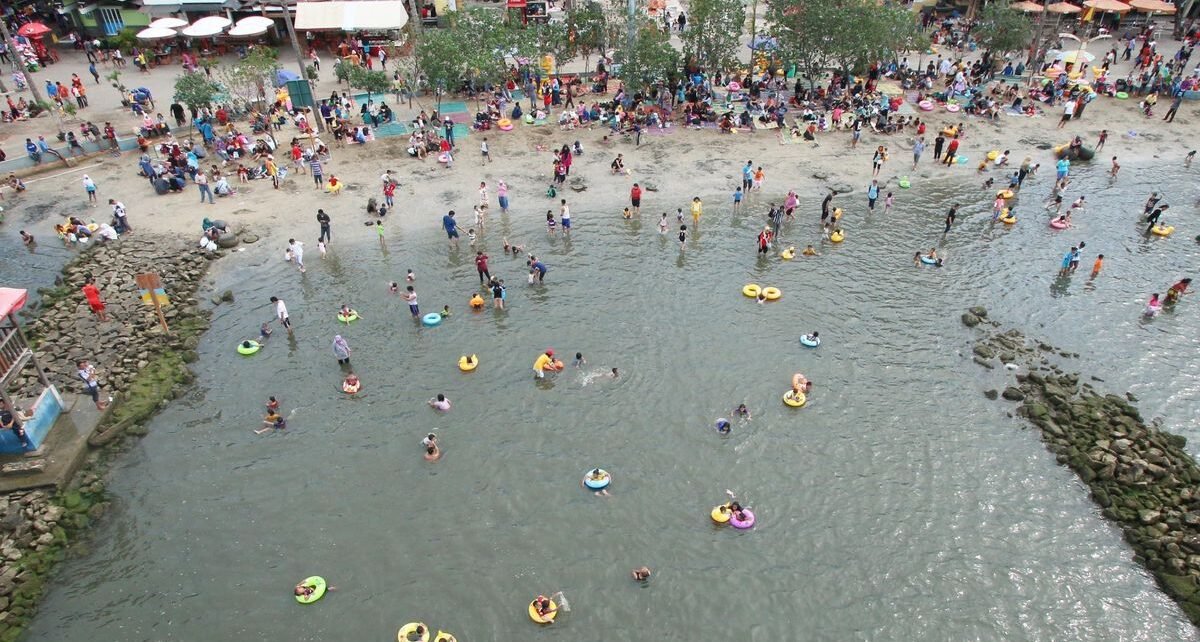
{"left": 16, "top": 157, "right": 1200, "bottom": 642}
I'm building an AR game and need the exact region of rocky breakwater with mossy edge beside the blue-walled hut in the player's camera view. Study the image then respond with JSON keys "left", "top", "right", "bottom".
{"left": 0, "top": 235, "right": 216, "bottom": 642}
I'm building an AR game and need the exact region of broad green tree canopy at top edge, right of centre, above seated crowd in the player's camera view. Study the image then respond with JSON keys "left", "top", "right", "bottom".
{"left": 767, "top": 0, "right": 926, "bottom": 85}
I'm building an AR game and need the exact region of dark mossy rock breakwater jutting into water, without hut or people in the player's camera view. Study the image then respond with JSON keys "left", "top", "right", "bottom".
{"left": 962, "top": 308, "right": 1200, "bottom": 625}
